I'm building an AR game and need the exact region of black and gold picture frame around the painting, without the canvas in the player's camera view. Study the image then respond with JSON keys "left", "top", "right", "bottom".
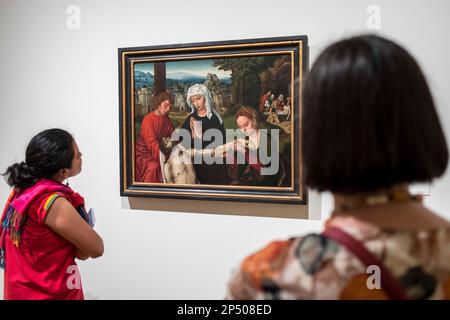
{"left": 119, "top": 36, "right": 308, "bottom": 205}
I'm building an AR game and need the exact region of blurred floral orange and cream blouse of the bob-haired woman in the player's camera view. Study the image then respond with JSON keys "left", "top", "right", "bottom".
{"left": 227, "top": 217, "right": 450, "bottom": 299}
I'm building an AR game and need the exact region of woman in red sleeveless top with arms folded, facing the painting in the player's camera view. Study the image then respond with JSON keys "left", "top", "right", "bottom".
{"left": 0, "top": 129, "right": 103, "bottom": 300}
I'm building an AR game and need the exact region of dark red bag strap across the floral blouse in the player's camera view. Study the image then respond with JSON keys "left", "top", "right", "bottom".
{"left": 322, "top": 227, "right": 408, "bottom": 300}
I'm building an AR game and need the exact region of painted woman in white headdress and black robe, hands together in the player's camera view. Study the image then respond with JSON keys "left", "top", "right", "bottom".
{"left": 182, "top": 84, "right": 230, "bottom": 184}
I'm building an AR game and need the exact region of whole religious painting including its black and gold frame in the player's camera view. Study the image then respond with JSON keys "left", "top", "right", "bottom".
{"left": 118, "top": 36, "right": 308, "bottom": 205}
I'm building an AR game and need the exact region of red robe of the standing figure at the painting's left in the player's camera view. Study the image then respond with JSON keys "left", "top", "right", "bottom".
{"left": 135, "top": 112, "right": 174, "bottom": 182}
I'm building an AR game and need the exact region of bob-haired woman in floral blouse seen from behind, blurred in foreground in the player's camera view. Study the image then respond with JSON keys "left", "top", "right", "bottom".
{"left": 228, "top": 36, "right": 450, "bottom": 299}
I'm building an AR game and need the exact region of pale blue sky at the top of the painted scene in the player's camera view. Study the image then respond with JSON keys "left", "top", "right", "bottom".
{"left": 135, "top": 60, "right": 231, "bottom": 80}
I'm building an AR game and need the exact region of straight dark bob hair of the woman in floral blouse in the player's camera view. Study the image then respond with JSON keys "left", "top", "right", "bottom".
{"left": 302, "top": 35, "right": 448, "bottom": 194}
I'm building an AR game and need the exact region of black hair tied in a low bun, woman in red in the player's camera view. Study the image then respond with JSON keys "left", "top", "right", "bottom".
{"left": 3, "top": 129, "right": 74, "bottom": 190}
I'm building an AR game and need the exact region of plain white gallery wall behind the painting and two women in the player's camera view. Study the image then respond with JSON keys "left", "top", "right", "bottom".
{"left": 0, "top": 0, "right": 450, "bottom": 299}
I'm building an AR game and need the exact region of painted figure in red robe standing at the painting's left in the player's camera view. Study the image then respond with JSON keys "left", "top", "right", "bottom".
{"left": 135, "top": 92, "right": 174, "bottom": 182}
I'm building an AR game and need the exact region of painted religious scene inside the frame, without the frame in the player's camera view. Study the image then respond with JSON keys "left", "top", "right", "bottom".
{"left": 132, "top": 54, "right": 293, "bottom": 188}
